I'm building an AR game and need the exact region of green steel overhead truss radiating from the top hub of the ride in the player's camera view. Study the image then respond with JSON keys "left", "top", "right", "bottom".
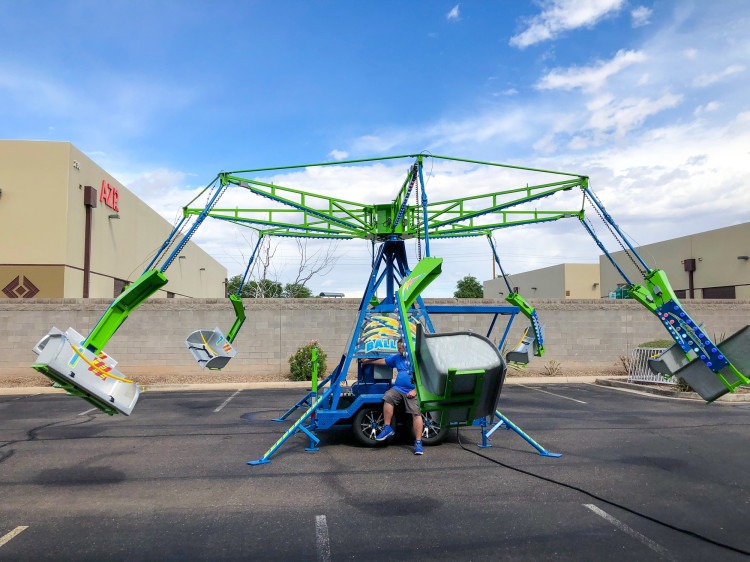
{"left": 183, "top": 154, "right": 588, "bottom": 240}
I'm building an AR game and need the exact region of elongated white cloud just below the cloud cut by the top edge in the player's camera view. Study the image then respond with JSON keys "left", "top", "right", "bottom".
{"left": 535, "top": 50, "right": 646, "bottom": 92}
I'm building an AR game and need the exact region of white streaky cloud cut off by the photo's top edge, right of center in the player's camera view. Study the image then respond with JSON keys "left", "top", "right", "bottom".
{"left": 510, "top": 0, "right": 625, "bottom": 49}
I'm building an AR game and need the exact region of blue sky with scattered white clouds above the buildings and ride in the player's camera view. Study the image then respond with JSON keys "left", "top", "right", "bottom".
{"left": 0, "top": 0, "right": 750, "bottom": 296}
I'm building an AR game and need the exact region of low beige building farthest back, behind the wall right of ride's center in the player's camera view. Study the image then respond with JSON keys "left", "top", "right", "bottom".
{"left": 484, "top": 263, "right": 599, "bottom": 299}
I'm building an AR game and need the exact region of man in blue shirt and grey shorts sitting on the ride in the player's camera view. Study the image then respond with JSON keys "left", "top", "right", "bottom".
{"left": 362, "top": 339, "right": 424, "bottom": 455}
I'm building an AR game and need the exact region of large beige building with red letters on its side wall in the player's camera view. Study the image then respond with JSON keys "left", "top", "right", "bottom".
{"left": 0, "top": 140, "right": 227, "bottom": 299}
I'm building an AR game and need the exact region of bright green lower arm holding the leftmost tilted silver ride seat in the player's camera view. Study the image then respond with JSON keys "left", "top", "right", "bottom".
{"left": 83, "top": 269, "right": 167, "bottom": 353}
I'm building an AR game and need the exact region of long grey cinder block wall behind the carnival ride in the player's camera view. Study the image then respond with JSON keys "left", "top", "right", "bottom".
{"left": 0, "top": 299, "right": 750, "bottom": 376}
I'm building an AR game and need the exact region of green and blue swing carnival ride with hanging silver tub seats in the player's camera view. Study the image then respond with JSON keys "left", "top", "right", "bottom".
{"left": 33, "top": 154, "right": 750, "bottom": 464}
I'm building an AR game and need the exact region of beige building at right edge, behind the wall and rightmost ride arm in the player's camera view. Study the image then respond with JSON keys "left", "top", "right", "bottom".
{"left": 599, "top": 222, "right": 750, "bottom": 299}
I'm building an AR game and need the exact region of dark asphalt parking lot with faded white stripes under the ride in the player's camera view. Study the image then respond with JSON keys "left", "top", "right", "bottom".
{"left": 0, "top": 384, "right": 750, "bottom": 561}
